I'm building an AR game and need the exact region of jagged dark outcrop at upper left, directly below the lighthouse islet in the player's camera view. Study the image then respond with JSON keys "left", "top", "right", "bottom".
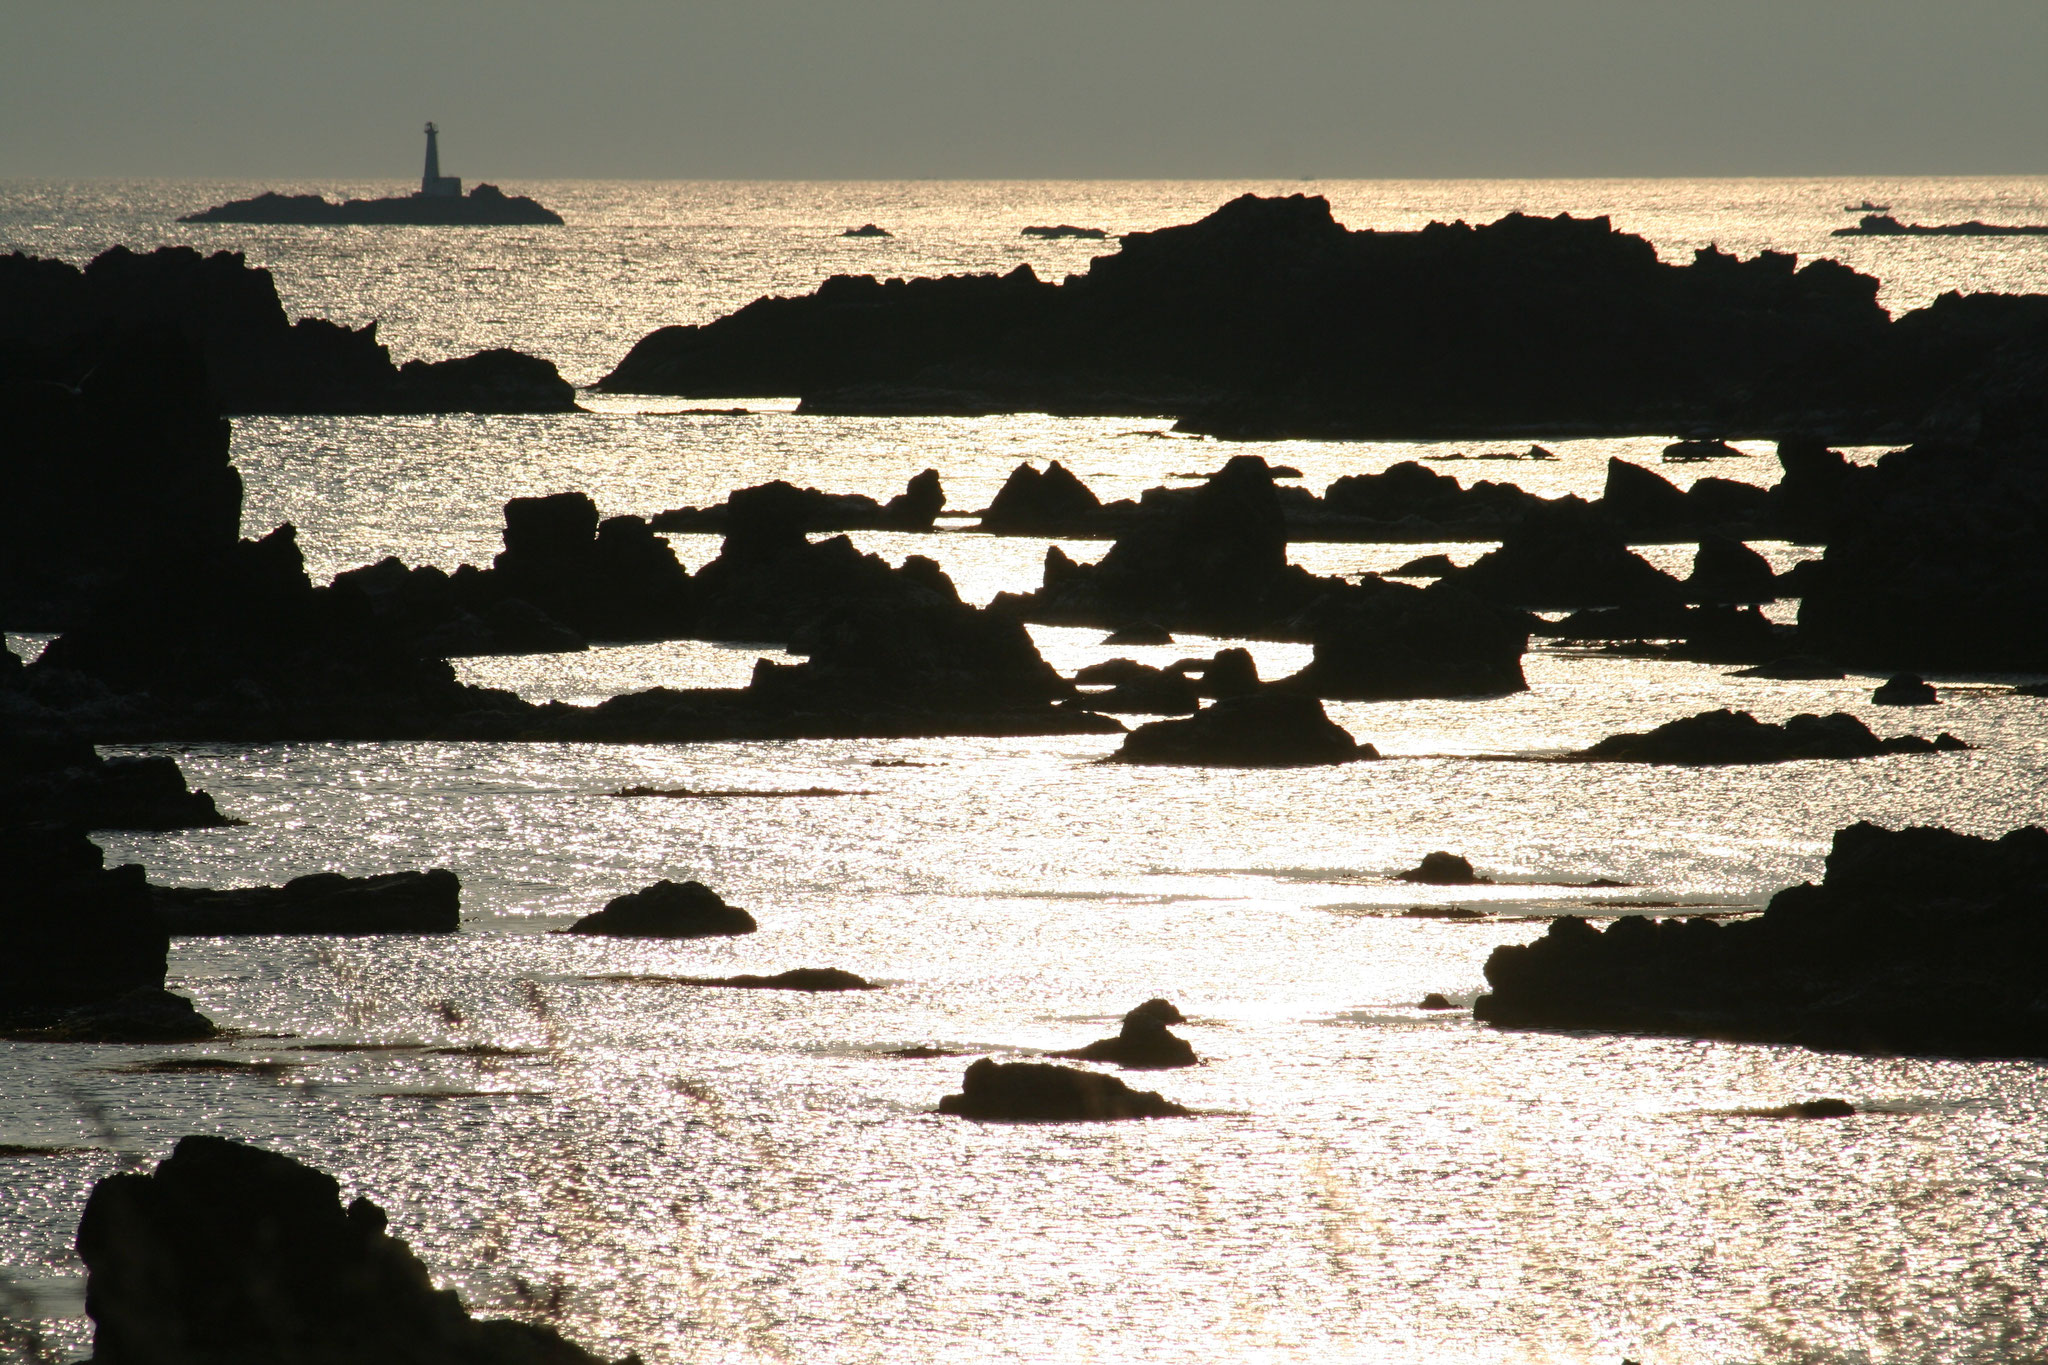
{"left": 0, "top": 246, "right": 575, "bottom": 413}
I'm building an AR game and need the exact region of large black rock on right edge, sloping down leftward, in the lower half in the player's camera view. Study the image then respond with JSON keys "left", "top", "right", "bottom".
{"left": 1475, "top": 825, "right": 2048, "bottom": 1056}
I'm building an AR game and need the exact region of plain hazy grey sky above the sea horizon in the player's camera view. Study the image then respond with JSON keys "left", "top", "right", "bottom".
{"left": 0, "top": 0, "right": 2048, "bottom": 180}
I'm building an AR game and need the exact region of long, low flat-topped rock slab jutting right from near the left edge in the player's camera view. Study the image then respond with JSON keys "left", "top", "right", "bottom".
{"left": 150, "top": 868, "right": 463, "bottom": 937}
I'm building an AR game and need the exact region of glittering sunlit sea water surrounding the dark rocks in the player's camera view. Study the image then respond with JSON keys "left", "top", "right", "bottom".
{"left": 0, "top": 178, "right": 2048, "bottom": 1365}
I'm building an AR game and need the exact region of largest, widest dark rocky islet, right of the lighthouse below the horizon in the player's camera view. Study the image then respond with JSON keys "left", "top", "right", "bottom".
{"left": 600, "top": 194, "right": 2042, "bottom": 440}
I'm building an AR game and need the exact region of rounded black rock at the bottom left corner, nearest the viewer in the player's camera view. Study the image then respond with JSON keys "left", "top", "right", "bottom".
{"left": 78, "top": 1136, "right": 622, "bottom": 1365}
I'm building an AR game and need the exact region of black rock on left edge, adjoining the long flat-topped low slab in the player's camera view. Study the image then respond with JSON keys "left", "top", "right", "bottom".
{"left": 0, "top": 823, "right": 213, "bottom": 1042}
